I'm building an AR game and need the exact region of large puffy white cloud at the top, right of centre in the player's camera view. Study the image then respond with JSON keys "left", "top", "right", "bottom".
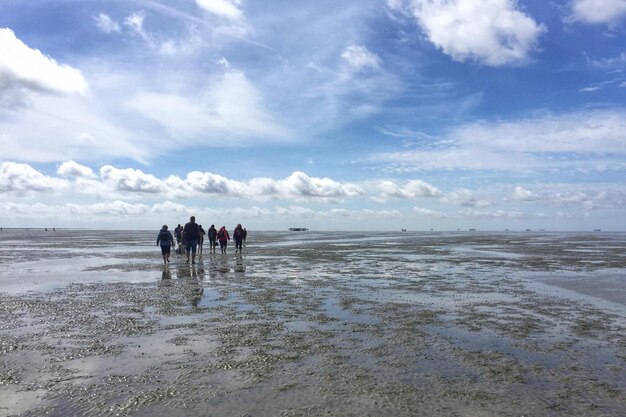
{"left": 404, "top": 0, "right": 546, "bottom": 66}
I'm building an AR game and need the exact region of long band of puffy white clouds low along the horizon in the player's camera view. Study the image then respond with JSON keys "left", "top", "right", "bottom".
{"left": 0, "top": 161, "right": 626, "bottom": 230}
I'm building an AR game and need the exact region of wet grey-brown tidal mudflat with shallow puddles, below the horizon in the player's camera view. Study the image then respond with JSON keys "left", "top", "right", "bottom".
{"left": 0, "top": 230, "right": 626, "bottom": 417}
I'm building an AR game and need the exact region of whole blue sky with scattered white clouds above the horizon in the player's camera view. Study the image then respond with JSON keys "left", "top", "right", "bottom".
{"left": 0, "top": 0, "right": 626, "bottom": 231}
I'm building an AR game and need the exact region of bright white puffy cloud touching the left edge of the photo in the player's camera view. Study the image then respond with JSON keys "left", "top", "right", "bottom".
{"left": 0, "top": 28, "right": 88, "bottom": 107}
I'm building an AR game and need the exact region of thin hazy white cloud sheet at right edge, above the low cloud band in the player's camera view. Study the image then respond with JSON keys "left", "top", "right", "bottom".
{"left": 375, "top": 109, "right": 626, "bottom": 172}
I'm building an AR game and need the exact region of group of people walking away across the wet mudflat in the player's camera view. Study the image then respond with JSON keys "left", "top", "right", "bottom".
{"left": 157, "top": 216, "right": 248, "bottom": 264}
